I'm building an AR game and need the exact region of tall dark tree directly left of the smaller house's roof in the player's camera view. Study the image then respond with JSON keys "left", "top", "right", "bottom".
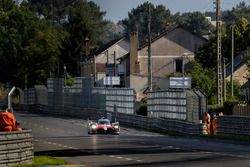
{"left": 61, "top": 0, "right": 109, "bottom": 76}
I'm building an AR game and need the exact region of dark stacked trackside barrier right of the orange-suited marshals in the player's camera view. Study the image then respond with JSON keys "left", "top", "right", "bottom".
{"left": 217, "top": 115, "right": 250, "bottom": 136}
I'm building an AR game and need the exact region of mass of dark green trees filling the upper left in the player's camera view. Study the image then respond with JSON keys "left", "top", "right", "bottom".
{"left": 0, "top": 0, "right": 115, "bottom": 87}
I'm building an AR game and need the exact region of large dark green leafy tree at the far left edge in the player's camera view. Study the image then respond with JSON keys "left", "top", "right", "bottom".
{"left": 0, "top": 0, "right": 62, "bottom": 87}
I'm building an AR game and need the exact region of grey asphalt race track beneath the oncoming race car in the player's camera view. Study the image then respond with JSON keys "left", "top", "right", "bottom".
{"left": 15, "top": 113, "right": 250, "bottom": 167}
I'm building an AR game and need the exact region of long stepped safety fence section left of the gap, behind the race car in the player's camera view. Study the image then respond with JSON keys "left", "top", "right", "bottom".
{"left": 47, "top": 78, "right": 135, "bottom": 114}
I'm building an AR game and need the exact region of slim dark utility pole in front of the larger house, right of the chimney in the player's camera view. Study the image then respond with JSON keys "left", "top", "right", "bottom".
{"left": 148, "top": 3, "right": 152, "bottom": 91}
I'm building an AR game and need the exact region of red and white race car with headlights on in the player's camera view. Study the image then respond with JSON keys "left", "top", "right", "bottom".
{"left": 87, "top": 118, "right": 120, "bottom": 135}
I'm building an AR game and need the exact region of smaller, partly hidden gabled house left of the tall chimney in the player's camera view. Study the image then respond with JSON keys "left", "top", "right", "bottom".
{"left": 81, "top": 38, "right": 129, "bottom": 86}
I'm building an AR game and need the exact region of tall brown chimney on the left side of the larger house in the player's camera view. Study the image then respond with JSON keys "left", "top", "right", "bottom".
{"left": 129, "top": 32, "right": 139, "bottom": 74}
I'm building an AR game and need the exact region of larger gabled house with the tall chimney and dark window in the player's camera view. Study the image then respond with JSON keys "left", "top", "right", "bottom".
{"left": 119, "top": 26, "right": 207, "bottom": 92}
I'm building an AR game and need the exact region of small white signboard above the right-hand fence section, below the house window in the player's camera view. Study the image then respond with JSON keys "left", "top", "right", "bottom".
{"left": 169, "top": 77, "right": 192, "bottom": 89}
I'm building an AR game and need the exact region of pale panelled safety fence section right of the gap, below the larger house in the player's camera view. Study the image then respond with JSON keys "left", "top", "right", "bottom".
{"left": 148, "top": 89, "right": 207, "bottom": 123}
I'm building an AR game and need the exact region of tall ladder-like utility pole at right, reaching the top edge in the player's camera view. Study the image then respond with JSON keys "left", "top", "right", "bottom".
{"left": 216, "top": 0, "right": 223, "bottom": 105}
